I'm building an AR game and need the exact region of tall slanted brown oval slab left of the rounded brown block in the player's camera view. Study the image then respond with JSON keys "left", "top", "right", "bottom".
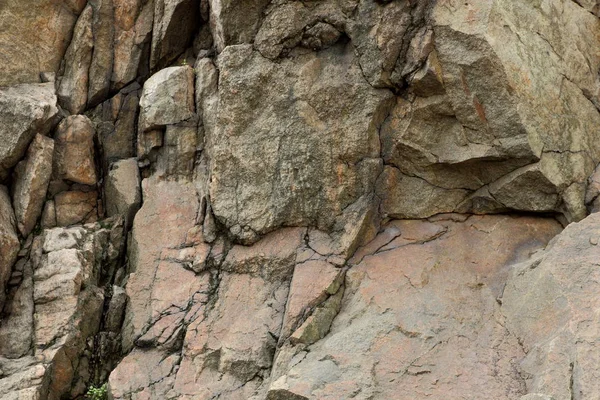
{"left": 12, "top": 135, "right": 54, "bottom": 237}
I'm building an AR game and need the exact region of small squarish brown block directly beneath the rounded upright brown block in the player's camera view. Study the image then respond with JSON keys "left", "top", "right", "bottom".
{"left": 54, "top": 191, "right": 98, "bottom": 226}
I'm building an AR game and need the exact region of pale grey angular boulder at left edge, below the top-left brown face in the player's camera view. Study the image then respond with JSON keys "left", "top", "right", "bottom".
{"left": 0, "top": 83, "right": 59, "bottom": 180}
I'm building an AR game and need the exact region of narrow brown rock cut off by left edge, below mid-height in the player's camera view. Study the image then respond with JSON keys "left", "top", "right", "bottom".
{"left": 0, "top": 185, "right": 21, "bottom": 309}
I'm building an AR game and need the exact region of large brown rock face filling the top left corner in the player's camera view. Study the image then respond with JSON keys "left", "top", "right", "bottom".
{"left": 0, "top": 0, "right": 85, "bottom": 86}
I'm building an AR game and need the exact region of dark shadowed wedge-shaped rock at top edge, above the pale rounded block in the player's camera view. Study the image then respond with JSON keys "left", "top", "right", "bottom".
{"left": 150, "top": 0, "right": 200, "bottom": 70}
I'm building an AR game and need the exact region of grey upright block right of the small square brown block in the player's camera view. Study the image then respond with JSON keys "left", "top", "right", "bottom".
{"left": 104, "top": 158, "right": 142, "bottom": 228}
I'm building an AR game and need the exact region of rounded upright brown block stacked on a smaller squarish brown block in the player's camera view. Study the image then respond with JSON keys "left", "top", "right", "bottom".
{"left": 53, "top": 115, "right": 98, "bottom": 185}
